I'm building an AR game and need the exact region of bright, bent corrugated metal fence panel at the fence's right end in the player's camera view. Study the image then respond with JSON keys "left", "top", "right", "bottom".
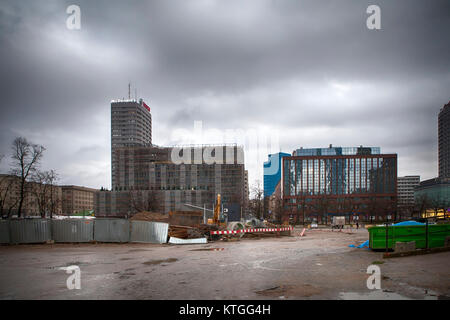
{"left": 131, "top": 221, "right": 169, "bottom": 243}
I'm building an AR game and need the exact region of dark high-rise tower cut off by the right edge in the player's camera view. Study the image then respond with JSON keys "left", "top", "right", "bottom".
{"left": 438, "top": 102, "right": 450, "bottom": 180}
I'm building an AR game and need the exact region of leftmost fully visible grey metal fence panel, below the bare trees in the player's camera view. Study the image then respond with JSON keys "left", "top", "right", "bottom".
{"left": 9, "top": 219, "right": 52, "bottom": 243}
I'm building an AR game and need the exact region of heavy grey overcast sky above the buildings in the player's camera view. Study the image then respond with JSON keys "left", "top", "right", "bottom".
{"left": 0, "top": 0, "right": 450, "bottom": 188}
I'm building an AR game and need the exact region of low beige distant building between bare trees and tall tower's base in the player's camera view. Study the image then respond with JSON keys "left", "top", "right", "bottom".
{"left": 61, "top": 186, "right": 98, "bottom": 215}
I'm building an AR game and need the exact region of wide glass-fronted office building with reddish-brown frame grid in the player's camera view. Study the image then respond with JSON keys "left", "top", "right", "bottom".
{"left": 281, "top": 145, "right": 397, "bottom": 223}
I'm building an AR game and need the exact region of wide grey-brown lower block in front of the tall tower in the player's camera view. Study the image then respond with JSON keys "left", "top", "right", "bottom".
{"left": 96, "top": 145, "right": 247, "bottom": 216}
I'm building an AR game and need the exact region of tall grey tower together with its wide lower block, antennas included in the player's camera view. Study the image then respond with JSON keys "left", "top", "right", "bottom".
{"left": 95, "top": 93, "right": 248, "bottom": 217}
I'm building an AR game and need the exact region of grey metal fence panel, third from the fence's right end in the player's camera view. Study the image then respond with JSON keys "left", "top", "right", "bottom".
{"left": 52, "top": 219, "right": 94, "bottom": 242}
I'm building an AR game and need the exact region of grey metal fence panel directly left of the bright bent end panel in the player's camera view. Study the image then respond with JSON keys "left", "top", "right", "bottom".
{"left": 94, "top": 218, "right": 130, "bottom": 242}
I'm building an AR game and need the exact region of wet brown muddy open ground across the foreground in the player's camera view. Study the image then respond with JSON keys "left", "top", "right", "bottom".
{"left": 0, "top": 229, "right": 450, "bottom": 299}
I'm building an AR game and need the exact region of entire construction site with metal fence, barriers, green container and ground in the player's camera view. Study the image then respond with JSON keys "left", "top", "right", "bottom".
{"left": 0, "top": 195, "right": 450, "bottom": 300}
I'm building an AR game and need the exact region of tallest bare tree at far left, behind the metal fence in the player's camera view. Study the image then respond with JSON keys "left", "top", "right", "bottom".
{"left": 12, "top": 137, "right": 45, "bottom": 218}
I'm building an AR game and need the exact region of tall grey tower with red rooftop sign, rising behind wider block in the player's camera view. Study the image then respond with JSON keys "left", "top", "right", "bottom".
{"left": 111, "top": 99, "right": 152, "bottom": 190}
